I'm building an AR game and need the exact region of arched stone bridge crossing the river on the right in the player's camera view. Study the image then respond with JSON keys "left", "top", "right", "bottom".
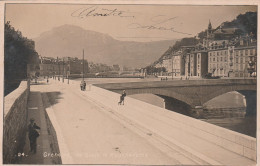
{"left": 96, "top": 79, "right": 257, "bottom": 117}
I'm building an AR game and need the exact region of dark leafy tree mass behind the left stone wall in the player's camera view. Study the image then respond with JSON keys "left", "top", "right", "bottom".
{"left": 4, "top": 21, "right": 39, "bottom": 95}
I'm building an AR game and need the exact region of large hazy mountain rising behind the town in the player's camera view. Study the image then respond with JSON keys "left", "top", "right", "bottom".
{"left": 34, "top": 25, "right": 175, "bottom": 67}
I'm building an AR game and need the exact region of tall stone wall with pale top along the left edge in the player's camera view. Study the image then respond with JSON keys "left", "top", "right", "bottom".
{"left": 3, "top": 81, "right": 30, "bottom": 164}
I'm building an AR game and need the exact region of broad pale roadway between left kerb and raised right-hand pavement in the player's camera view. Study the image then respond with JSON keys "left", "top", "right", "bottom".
{"left": 38, "top": 80, "right": 198, "bottom": 165}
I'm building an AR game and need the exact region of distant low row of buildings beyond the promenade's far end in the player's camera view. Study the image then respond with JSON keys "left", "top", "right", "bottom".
{"left": 27, "top": 57, "right": 132, "bottom": 77}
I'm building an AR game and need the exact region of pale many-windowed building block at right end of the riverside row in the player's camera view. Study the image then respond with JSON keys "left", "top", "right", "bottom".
{"left": 208, "top": 46, "right": 257, "bottom": 77}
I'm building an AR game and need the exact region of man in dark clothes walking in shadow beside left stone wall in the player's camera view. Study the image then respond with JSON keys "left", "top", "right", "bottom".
{"left": 28, "top": 118, "right": 41, "bottom": 153}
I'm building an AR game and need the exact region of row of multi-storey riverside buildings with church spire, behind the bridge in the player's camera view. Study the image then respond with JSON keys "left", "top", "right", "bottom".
{"left": 151, "top": 23, "right": 257, "bottom": 77}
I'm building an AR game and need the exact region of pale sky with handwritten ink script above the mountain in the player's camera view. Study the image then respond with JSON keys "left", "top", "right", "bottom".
{"left": 5, "top": 4, "right": 257, "bottom": 42}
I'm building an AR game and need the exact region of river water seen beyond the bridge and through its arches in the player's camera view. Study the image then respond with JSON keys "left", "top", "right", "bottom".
{"left": 77, "top": 78, "right": 256, "bottom": 137}
